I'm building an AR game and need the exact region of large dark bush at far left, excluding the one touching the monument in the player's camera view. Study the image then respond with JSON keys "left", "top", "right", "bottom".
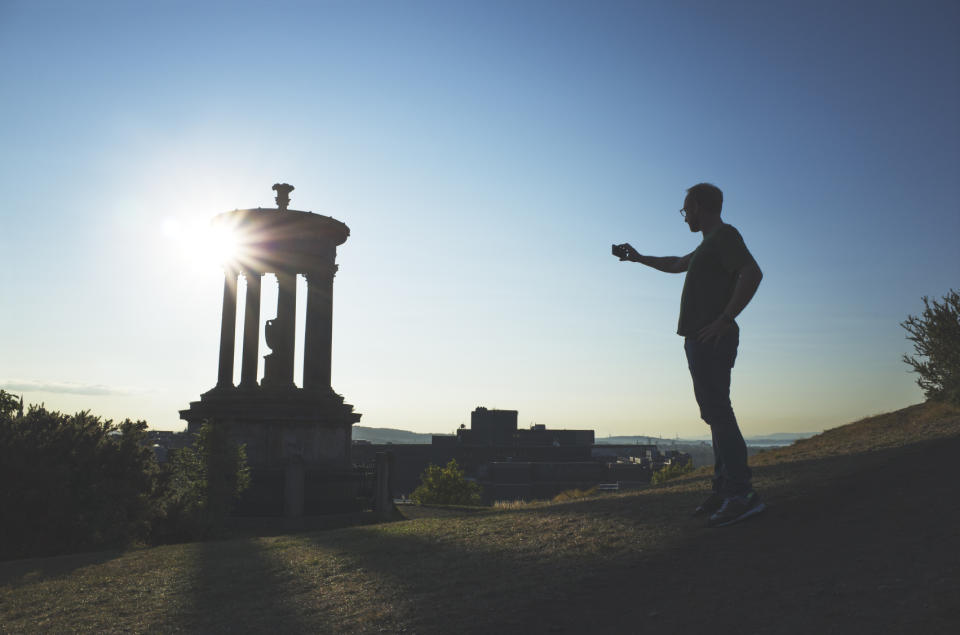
{"left": 0, "top": 391, "right": 158, "bottom": 559}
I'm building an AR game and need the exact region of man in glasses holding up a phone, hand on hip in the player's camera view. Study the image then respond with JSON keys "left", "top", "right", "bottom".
{"left": 613, "top": 183, "right": 765, "bottom": 527}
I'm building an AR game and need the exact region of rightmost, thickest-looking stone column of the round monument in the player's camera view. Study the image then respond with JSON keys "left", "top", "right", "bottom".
{"left": 303, "top": 265, "right": 337, "bottom": 390}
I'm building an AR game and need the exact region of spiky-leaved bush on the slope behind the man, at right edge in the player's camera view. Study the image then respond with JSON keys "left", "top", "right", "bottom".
{"left": 900, "top": 289, "right": 960, "bottom": 404}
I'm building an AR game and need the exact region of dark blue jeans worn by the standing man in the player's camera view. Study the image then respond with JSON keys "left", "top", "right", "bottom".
{"left": 684, "top": 326, "right": 752, "bottom": 496}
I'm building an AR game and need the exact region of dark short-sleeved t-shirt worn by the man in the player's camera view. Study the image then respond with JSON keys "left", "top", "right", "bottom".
{"left": 677, "top": 224, "right": 755, "bottom": 337}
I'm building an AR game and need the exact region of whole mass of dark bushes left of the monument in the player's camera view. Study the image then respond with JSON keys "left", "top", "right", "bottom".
{"left": 0, "top": 390, "right": 250, "bottom": 560}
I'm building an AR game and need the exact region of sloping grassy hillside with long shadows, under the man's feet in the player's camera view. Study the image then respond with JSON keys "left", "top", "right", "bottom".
{"left": 0, "top": 404, "right": 960, "bottom": 634}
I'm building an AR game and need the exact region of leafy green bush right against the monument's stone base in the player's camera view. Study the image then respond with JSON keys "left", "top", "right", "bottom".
{"left": 155, "top": 423, "right": 250, "bottom": 542}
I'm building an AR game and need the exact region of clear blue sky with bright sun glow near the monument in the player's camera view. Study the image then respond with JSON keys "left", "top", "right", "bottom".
{"left": 0, "top": 0, "right": 960, "bottom": 437}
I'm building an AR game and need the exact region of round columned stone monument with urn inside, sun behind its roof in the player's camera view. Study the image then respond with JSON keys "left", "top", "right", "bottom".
{"left": 180, "top": 183, "right": 361, "bottom": 517}
